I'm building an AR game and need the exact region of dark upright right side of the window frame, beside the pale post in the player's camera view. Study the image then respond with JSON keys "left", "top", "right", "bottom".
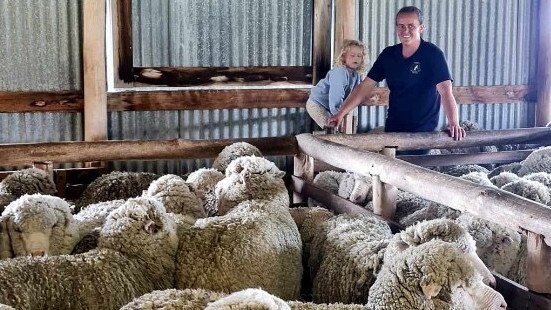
{"left": 312, "top": 0, "right": 331, "bottom": 84}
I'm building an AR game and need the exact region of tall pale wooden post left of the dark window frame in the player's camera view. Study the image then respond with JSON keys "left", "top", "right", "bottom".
{"left": 83, "top": 0, "right": 107, "bottom": 141}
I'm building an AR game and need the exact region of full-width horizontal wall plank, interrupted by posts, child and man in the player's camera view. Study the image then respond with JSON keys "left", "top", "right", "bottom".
{"left": 0, "top": 85, "right": 528, "bottom": 113}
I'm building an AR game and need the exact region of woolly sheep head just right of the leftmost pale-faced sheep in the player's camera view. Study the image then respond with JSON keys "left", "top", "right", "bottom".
{"left": 98, "top": 197, "right": 178, "bottom": 259}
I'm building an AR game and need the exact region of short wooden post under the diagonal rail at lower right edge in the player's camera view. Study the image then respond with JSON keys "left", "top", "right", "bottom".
{"left": 526, "top": 231, "right": 551, "bottom": 294}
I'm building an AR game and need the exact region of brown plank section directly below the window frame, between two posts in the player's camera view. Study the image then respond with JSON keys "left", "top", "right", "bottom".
{"left": 109, "top": 89, "right": 309, "bottom": 111}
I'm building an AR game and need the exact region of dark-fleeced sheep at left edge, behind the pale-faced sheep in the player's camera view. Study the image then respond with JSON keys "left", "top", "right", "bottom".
{"left": 0, "top": 168, "right": 57, "bottom": 197}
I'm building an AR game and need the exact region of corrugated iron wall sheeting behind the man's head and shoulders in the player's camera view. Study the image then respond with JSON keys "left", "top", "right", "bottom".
{"left": 359, "top": 0, "right": 538, "bottom": 86}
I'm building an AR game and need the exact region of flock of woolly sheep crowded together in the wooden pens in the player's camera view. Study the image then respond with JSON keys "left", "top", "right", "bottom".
{"left": 0, "top": 142, "right": 551, "bottom": 310}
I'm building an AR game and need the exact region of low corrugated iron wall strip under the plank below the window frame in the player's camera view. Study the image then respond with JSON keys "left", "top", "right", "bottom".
{"left": 109, "top": 108, "right": 312, "bottom": 174}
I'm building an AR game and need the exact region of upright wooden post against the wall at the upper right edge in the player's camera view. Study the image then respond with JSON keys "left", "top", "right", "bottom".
{"left": 536, "top": 0, "right": 551, "bottom": 126}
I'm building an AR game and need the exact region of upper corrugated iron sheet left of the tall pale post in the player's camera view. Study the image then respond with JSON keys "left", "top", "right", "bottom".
{"left": 0, "top": 0, "right": 82, "bottom": 91}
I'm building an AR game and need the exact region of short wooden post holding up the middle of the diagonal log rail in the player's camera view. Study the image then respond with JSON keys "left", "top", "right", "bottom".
{"left": 372, "top": 147, "right": 398, "bottom": 220}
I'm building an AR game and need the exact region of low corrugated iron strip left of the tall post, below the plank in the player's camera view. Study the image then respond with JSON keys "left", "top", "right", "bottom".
{"left": 0, "top": 112, "right": 84, "bottom": 170}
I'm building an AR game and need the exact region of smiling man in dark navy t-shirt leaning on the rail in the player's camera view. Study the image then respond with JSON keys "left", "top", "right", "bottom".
{"left": 328, "top": 6, "right": 465, "bottom": 145}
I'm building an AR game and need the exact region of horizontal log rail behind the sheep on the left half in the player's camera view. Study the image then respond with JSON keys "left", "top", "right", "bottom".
{"left": 0, "top": 137, "right": 298, "bottom": 166}
